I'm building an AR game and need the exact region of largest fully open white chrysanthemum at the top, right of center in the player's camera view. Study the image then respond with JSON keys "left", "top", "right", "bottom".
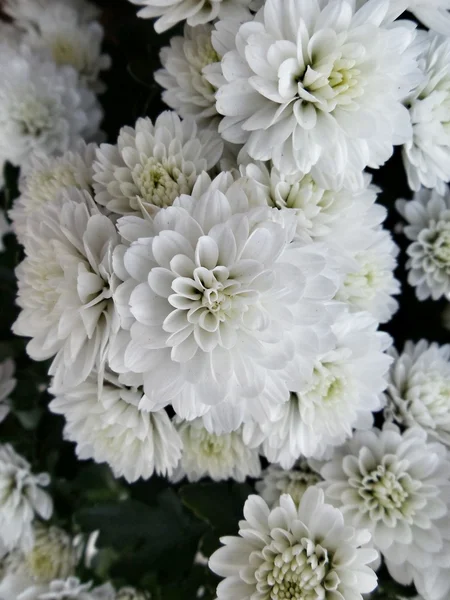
{"left": 216, "top": 0, "right": 420, "bottom": 187}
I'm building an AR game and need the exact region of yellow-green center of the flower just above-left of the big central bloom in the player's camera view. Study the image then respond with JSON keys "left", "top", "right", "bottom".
{"left": 133, "top": 157, "right": 191, "bottom": 208}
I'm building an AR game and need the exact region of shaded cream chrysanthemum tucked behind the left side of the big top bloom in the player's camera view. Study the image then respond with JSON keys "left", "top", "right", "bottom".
{"left": 155, "top": 25, "right": 220, "bottom": 126}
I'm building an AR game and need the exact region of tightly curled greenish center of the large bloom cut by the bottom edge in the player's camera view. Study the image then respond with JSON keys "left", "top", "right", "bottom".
{"left": 255, "top": 538, "right": 339, "bottom": 600}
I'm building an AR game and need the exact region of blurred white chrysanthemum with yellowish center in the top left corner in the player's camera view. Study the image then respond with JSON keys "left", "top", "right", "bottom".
{"left": 5, "top": 0, "right": 111, "bottom": 92}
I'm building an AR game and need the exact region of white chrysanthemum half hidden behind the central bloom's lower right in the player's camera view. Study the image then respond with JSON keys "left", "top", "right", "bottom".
{"left": 244, "top": 313, "right": 392, "bottom": 469}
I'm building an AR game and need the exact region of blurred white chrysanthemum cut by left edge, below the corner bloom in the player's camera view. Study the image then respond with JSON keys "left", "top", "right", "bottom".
{"left": 0, "top": 45, "right": 102, "bottom": 169}
